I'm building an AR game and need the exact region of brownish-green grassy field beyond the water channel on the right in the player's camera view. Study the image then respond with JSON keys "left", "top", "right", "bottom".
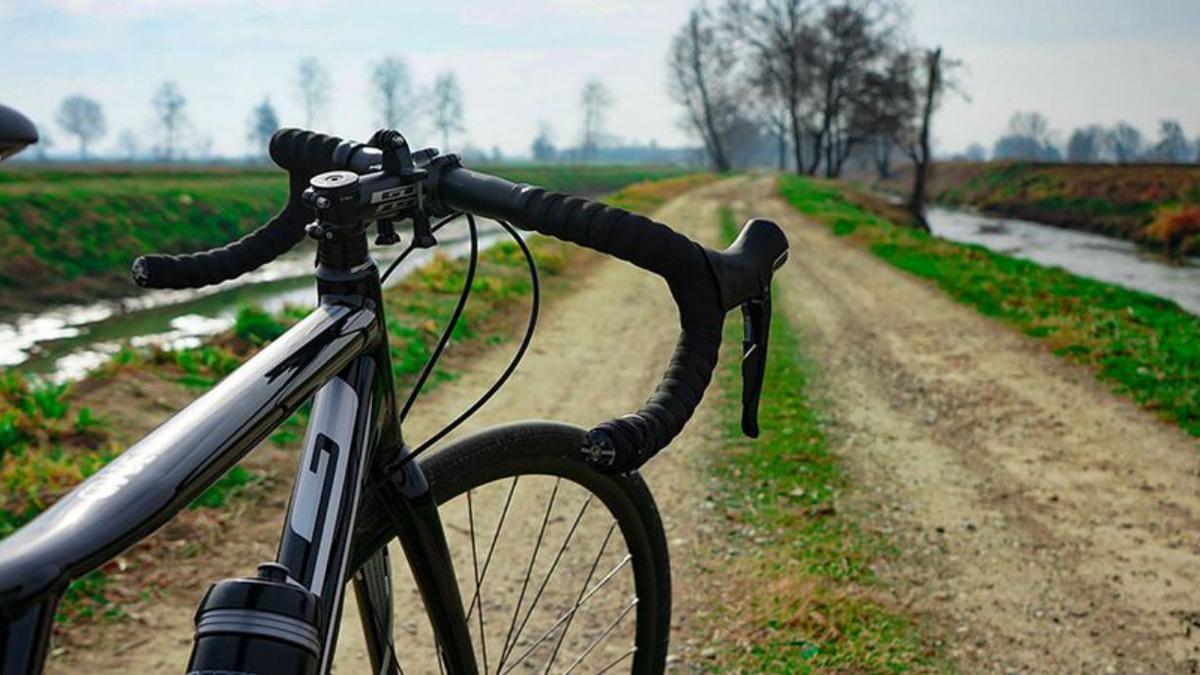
{"left": 883, "top": 162, "right": 1200, "bottom": 253}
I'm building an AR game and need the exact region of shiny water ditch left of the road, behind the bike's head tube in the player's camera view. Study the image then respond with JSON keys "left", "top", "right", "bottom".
{"left": 0, "top": 222, "right": 503, "bottom": 382}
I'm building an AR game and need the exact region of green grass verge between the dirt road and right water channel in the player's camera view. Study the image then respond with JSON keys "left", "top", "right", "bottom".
{"left": 780, "top": 177, "right": 1200, "bottom": 436}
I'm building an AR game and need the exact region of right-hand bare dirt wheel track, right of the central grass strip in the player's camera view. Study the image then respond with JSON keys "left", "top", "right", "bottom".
{"left": 738, "top": 179, "right": 1200, "bottom": 673}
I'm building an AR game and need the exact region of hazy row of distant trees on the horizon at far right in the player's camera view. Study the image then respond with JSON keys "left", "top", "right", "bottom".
{"left": 965, "top": 112, "right": 1200, "bottom": 165}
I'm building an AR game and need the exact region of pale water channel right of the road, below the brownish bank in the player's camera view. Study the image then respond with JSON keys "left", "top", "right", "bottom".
{"left": 926, "top": 208, "right": 1200, "bottom": 315}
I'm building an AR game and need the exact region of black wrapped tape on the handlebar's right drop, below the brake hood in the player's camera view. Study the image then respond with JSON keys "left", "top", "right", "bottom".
{"left": 514, "top": 189, "right": 725, "bottom": 473}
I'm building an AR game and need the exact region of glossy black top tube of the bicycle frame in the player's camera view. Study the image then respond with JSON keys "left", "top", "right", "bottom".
{"left": 0, "top": 303, "right": 380, "bottom": 610}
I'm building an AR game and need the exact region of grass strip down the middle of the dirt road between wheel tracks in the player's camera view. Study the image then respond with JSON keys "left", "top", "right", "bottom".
{"left": 713, "top": 209, "right": 944, "bottom": 673}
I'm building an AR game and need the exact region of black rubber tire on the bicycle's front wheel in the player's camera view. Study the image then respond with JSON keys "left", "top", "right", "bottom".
{"left": 355, "top": 422, "right": 671, "bottom": 674}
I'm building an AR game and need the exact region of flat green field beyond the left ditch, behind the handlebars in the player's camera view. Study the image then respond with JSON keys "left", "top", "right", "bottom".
{"left": 0, "top": 166, "right": 684, "bottom": 311}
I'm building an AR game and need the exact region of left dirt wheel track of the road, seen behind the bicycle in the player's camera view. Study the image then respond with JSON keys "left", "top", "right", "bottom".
{"left": 56, "top": 179, "right": 745, "bottom": 673}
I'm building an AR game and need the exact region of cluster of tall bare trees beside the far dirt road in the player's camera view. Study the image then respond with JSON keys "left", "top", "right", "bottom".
{"left": 667, "top": 0, "right": 958, "bottom": 222}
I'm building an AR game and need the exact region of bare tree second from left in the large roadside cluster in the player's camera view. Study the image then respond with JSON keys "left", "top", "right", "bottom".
{"left": 724, "top": 0, "right": 812, "bottom": 172}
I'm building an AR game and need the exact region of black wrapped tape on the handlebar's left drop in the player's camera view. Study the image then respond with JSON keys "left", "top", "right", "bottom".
{"left": 133, "top": 129, "right": 364, "bottom": 288}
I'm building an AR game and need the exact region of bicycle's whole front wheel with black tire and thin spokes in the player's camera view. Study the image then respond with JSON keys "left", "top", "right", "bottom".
{"left": 355, "top": 422, "right": 671, "bottom": 674}
